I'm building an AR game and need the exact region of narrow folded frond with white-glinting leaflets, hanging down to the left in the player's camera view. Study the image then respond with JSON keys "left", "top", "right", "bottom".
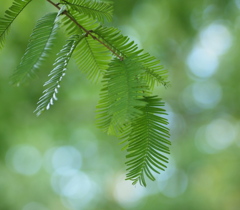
{"left": 34, "top": 35, "right": 84, "bottom": 115}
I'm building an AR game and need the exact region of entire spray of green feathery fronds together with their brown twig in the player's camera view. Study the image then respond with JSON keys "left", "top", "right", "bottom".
{"left": 0, "top": 0, "right": 170, "bottom": 186}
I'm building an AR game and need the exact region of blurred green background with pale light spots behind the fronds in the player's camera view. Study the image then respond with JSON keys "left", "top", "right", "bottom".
{"left": 0, "top": 0, "right": 240, "bottom": 210}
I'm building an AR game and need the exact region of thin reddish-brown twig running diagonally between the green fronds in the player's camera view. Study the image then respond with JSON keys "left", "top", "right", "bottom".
{"left": 47, "top": 0, "right": 124, "bottom": 61}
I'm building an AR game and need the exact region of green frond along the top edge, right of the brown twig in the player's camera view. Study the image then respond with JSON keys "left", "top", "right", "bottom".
{"left": 61, "top": 0, "right": 113, "bottom": 22}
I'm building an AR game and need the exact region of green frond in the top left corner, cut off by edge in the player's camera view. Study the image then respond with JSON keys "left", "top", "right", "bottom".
{"left": 0, "top": 0, "right": 32, "bottom": 49}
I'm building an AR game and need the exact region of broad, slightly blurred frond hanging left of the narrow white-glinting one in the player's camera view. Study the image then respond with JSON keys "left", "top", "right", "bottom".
{"left": 12, "top": 13, "right": 59, "bottom": 85}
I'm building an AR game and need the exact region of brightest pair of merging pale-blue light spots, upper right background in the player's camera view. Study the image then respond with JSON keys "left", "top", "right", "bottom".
{"left": 187, "top": 23, "right": 232, "bottom": 78}
